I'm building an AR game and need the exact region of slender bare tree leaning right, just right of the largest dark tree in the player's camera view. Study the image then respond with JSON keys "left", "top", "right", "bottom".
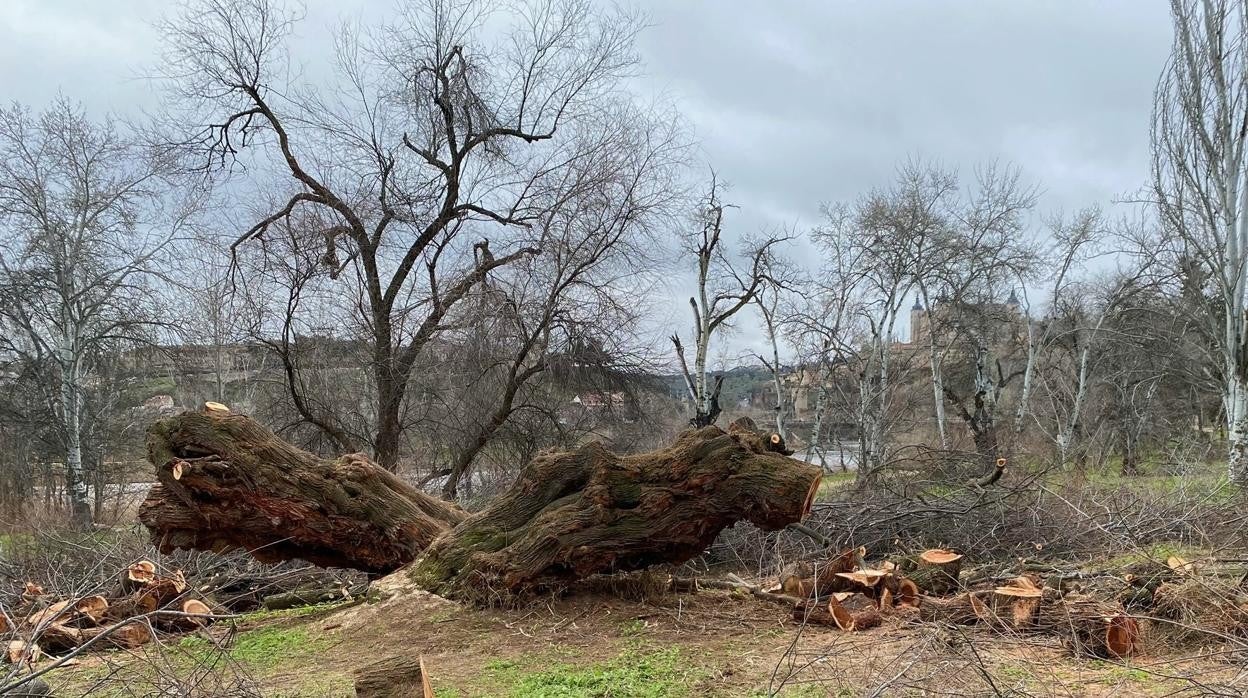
{"left": 431, "top": 109, "right": 684, "bottom": 499}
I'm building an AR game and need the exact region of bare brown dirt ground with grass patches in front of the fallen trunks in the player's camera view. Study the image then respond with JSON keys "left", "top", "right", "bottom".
{"left": 39, "top": 571, "right": 1248, "bottom": 698}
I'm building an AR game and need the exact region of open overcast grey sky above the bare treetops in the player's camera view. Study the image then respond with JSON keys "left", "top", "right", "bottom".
{"left": 0, "top": 0, "right": 1171, "bottom": 359}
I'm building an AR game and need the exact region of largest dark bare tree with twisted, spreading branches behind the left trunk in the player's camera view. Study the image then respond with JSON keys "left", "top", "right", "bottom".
{"left": 163, "top": 0, "right": 640, "bottom": 468}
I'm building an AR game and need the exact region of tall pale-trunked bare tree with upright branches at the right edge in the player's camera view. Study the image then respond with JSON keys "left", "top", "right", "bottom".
{"left": 1152, "top": 0, "right": 1248, "bottom": 486}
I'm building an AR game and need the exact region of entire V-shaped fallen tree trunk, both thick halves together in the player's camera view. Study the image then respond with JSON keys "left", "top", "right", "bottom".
{"left": 140, "top": 411, "right": 821, "bottom": 598}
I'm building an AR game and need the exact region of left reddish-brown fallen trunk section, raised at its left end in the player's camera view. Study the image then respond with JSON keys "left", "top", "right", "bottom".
{"left": 139, "top": 410, "right": 468, "bottom": 572}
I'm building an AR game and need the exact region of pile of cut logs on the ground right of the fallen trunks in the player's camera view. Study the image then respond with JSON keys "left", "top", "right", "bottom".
{"left": 768, "top": 548, "right": 1141, "bottom": 658}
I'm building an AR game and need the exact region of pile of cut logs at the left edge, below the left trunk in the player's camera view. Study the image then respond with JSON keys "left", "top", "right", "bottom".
{"left": 0, "top": 559, "right": 215, "bottom": 663}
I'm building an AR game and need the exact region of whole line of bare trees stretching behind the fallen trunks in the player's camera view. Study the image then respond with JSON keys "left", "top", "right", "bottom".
{"left": 0, "top": 0, "right": 1248, "bottom": 522}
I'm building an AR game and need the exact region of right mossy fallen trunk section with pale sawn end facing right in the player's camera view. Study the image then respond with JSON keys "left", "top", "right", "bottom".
{"left": 412, "top": 419, "right": 821, "bottom": 598}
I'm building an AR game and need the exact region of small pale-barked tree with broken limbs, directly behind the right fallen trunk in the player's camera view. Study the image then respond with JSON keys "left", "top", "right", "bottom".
{"left": 671, "top": 172, "right": 785, "bottom": 427}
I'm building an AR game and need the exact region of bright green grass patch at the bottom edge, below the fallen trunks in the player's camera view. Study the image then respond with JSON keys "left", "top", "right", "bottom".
{"left": 485, "top": 647, "right": 696, "bottom": 698}
